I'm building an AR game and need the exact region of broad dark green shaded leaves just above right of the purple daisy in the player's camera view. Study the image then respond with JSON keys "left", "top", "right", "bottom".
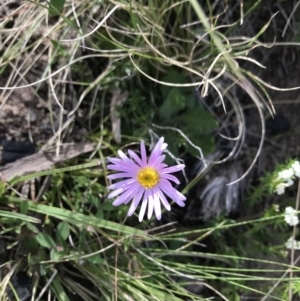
{"left": 159, "top": 69, "right": 218, "bottom": 156}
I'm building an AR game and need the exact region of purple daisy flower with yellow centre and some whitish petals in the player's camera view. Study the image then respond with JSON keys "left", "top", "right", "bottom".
{"left": 107, "top": 138, "right": 186, "bottom": 222}
